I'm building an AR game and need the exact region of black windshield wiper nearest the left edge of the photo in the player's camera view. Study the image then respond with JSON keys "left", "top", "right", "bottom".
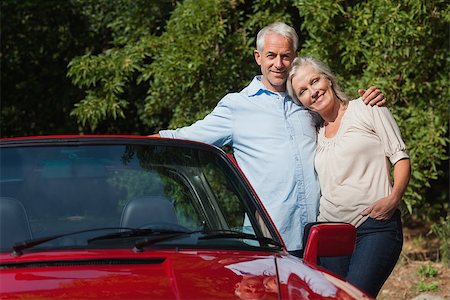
{"left": 12, "top": 227, "right": 143, "bottom": 256}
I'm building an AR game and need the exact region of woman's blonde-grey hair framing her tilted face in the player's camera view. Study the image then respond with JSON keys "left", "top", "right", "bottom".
{"left": 286, "top": 56, "right": 351, "bottom": 105}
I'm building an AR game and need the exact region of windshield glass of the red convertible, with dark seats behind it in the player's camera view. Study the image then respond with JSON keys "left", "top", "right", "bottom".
{"left": 0, "top": 139, "right": 274, "bottom": 251}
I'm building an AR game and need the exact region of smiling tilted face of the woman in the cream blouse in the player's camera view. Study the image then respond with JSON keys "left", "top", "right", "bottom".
{"left": 292, "top": 65, "right": 334, "bottom": 114}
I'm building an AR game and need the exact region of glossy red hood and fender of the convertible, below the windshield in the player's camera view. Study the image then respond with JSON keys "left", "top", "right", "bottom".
{"left": 0, "top": 250, "right": 370, "bottom": 299}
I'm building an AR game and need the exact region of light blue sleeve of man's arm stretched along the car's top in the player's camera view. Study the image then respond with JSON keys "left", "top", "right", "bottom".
{"left": 159, "top": 94, "right": 233, "bottom": 147}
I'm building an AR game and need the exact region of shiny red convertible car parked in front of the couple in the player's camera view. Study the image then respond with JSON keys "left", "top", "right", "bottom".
{"left": 0, "top": 136, "right": 369, "bottom": 299}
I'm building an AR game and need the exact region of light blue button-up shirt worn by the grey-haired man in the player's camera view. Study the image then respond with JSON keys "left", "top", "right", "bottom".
{"left": 159, "top": 76, "right": 320, "bottom": 251}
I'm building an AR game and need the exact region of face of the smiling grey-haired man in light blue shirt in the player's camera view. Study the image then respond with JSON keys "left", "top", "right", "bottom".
{"left": 255, "top": 32, "right": 295, "bottom": 92}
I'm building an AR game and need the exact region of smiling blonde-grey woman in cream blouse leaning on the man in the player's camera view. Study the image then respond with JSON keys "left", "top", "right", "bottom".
{"left": 287, "top": 57, "right": 410, "bottom": 297}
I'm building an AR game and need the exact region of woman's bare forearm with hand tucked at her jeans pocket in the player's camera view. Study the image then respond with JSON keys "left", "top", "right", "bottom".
{"left": 362, "top": 159, "right": 411, "bottom": 220}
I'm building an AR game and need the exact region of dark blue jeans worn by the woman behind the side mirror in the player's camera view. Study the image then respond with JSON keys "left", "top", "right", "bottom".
{"left": 319, "top": 210, "right": 403, "bottom": 297}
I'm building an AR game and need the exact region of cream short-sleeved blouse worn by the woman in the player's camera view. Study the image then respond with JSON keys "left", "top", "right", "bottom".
{"left": 315, "top": 98, "right": 409, "bottom": 226}
